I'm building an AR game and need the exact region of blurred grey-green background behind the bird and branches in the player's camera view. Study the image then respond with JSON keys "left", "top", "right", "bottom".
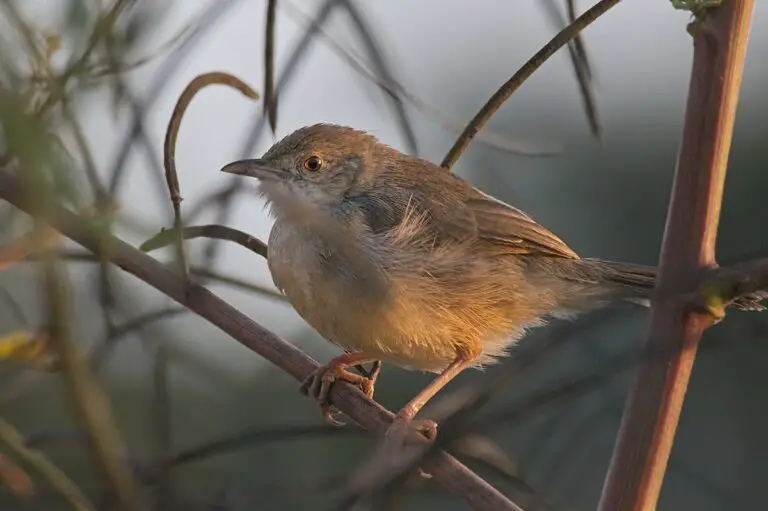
{"left": 0, "top": 0, "right": 768, "bottom": 511}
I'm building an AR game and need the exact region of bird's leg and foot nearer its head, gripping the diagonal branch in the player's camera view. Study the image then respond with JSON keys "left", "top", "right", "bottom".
{"left": 299, "top": 353, "right": 380, "bottom": 426}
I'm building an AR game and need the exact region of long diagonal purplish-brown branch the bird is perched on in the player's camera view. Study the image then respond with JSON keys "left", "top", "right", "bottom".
{"left": 0, "top": 171, "right": 519, "bottom": 511}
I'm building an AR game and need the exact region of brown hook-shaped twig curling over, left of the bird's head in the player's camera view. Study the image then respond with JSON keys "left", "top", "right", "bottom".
{"left": 163, "top": 71, "right": 259, "bottom": 275}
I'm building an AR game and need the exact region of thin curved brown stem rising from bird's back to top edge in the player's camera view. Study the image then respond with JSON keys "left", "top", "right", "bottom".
{"left": 441, "top": 0, "right": 620, "bottom": 169}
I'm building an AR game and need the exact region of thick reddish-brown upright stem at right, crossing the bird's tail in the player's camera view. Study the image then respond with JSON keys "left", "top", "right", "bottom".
{"left": 599, "top": 0, "right": 754, "bottom": 511}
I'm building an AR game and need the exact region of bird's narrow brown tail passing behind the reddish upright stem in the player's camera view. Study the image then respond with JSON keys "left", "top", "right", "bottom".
{"left": 574, "top": 259, "right": 768, "bottom": 311}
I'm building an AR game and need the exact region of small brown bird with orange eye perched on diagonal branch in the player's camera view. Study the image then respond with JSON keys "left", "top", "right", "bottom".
{"left": 222, "top": 124, "right": 762, "bottom": 434}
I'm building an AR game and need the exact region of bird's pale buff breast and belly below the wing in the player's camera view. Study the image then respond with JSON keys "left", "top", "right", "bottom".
{"left": 268, "top": 224, "right": 498, "bottom": 371}
